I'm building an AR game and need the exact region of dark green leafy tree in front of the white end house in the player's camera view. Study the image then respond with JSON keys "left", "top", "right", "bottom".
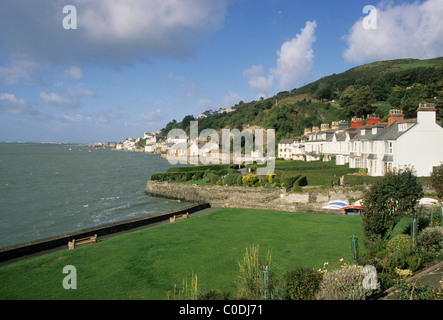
{"left": 363, "top": 168, "right": 424, "bottom": 248}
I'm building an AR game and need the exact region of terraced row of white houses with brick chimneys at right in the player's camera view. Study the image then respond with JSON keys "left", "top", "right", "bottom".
{"left": 278, "top": 103, "right": 443, "bottom": 176}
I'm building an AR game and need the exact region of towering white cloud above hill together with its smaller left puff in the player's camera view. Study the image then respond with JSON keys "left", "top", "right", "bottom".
{"left": 243, "top": 21, "right": 317, "bottom": 98}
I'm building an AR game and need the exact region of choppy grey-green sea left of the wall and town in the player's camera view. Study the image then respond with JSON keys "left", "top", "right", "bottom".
{"left": 0, "top": 143, "right": 190, "bottom": 248}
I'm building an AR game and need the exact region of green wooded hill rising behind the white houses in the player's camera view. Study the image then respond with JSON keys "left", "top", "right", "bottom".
{"left": 162, "top": 57, "right": 443, "bottom": 140}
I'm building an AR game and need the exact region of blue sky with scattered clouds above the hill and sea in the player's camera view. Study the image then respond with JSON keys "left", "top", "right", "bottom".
{"left": 0, "top": 0, "right": 443, "bottom": 143}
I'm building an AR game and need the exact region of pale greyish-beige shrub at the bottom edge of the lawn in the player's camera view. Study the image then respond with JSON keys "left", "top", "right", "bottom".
{"left": 317, "top": 265, "right": 380, "bottom": 300}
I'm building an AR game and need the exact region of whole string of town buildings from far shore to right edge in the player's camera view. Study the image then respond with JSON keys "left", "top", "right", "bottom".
{"left": 104, "top": 103, "right": 443, "bottom": 176}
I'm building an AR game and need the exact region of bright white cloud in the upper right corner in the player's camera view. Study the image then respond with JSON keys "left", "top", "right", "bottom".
{"left": 343, "top": 0, "right": 443, "bottom": 63}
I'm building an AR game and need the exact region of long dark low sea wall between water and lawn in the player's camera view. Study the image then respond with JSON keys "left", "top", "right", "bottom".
{"left": 0, "top": 201, "right": 210, "bottom": 262}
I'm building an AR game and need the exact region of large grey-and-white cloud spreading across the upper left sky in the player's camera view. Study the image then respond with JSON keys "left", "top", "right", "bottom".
{"left": 0, "top": 0, "right": 227, "bottom": 66}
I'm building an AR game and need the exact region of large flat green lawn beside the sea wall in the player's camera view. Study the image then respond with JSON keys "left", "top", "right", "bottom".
{"left": 0, "top": 209, "right": 410, "bottom": 299}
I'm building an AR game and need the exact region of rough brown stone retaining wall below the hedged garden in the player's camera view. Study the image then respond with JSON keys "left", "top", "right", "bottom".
{"left": 145, "top": 180, "right": 362, "bottom": 214}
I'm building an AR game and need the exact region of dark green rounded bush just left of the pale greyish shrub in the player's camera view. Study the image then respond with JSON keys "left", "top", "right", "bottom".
{"left": 283, "top": 267, "right": 323, "bottom": 300}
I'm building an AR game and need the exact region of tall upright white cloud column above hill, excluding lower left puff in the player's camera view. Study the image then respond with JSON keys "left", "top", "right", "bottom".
{"left": 271, "top": 21, "right": 317, "bottom": 90}
